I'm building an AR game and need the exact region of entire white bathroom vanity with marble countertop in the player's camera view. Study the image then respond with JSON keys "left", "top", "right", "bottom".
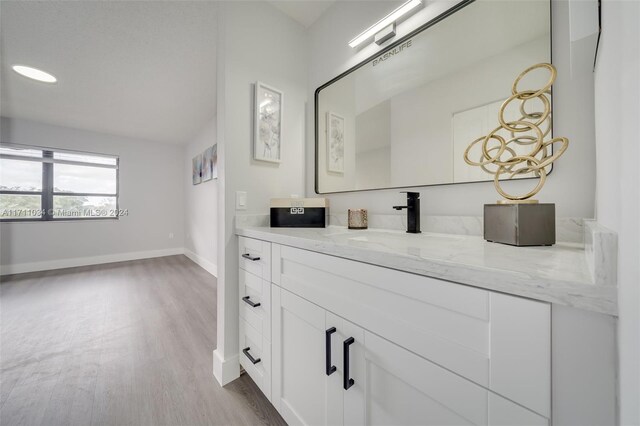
{"left": 237, "top": 225, "right": 617, "bottom": 425}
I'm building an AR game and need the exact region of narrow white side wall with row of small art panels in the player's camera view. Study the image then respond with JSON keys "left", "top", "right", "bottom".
{"left": 183, "top": 117, "right": 218, "bottom": 275}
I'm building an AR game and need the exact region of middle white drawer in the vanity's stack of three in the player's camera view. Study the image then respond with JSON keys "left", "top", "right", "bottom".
{"left": 238, "top": 269, "right": 271, "bottom": 341}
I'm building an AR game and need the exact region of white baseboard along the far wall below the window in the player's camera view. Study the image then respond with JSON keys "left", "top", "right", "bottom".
{"left": 0, "top": 247, "right": 185, "bottom": 275}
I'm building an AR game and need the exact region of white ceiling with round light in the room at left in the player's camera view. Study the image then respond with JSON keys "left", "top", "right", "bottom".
{"left": 0, "top": 0, "right": 217, "bottom": 143}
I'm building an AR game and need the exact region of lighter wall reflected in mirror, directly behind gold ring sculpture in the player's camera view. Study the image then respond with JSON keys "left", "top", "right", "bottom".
{"left": 390, "top": 36, "right": 549, "bottom": 186}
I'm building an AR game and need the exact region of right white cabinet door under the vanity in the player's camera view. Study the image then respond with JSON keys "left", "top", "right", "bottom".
{"left": 344, "top": 332, "right": 548, "bottom": 426}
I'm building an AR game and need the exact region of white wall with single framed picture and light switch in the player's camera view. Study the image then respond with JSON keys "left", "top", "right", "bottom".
{"left": 214, "top": 2, "right": 308, "bottom": 384}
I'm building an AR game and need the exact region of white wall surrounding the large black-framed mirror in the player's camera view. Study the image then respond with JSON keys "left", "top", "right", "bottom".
{"left": 306, "top": 0, "right": 595, "bottom": 217}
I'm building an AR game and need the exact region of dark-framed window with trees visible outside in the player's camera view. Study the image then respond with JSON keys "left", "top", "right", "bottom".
{"left": 0, "top": 145, "right": 121, "bottom": 222}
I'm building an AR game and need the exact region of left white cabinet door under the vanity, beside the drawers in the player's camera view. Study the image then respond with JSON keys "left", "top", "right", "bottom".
{"left": 272, "top": 285, "right": 342, "bottom": 426}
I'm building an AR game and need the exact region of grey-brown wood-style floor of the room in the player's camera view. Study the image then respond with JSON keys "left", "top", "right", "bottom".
{"left": 0, "top": 256, "right": 285, "bottom": 426}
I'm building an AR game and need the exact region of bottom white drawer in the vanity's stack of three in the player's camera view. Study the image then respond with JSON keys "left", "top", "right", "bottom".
{"left": 240, "top": 318, "right": 271, "bottom": 401}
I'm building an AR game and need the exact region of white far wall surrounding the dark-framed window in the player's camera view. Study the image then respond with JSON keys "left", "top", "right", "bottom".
{"left": 0, "top": 118, "right": 184, "bottom": 273}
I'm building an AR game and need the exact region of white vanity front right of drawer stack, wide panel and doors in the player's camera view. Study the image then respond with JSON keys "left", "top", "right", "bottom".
{"left": 272, "top": 244, "right": 551, "bottom": 426}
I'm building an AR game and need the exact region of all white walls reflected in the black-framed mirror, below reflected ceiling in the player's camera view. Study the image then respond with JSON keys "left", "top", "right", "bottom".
{"left": 317, "top": 35, "right": 549, "bottom": 192}
